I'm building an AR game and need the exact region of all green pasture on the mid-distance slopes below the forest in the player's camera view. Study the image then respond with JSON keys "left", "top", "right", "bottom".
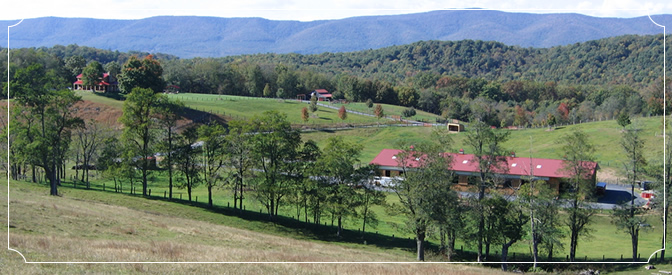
{"left": 72, "top": 90, "right": 663, "bottom": 169}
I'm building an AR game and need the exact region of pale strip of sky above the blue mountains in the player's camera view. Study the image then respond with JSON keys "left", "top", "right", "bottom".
{"left": 0, "top": 0, "right": 672, "bottom": 21}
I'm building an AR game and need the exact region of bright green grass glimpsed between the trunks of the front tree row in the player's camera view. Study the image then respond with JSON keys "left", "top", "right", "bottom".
{"left": 56, "top": 168, "right": 662, "bottom": 261}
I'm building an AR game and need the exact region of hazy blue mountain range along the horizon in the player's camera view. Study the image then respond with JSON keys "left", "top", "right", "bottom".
{"left": 0, "top": 10, "right": 672, "bottom": 58}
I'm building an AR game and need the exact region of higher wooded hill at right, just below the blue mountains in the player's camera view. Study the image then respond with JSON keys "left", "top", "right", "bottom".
{"left": 221, "top": 35, "right": 670, "bottom": 86}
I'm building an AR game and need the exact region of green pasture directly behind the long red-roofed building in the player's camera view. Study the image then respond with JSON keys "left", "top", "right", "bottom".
{"left": 302, "top": 117, "right": 663, "bottom": 169}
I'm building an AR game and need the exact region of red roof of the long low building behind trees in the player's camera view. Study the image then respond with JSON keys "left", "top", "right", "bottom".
{"left": 371, "top": 149, "right": 597, "bottom": 178}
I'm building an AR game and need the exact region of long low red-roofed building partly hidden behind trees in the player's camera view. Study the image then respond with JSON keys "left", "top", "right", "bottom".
{"left": 371, "top": 149, "right": 599, "bottom": 191}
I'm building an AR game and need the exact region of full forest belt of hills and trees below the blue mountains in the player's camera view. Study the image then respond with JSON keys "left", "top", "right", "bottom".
{"left": 3, "top": 35, "right": 670, "bottom": 126}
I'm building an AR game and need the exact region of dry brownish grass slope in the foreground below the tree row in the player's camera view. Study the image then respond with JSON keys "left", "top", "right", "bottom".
{"left": 0, "top": 182, "right": 504, "bottom": 274}
